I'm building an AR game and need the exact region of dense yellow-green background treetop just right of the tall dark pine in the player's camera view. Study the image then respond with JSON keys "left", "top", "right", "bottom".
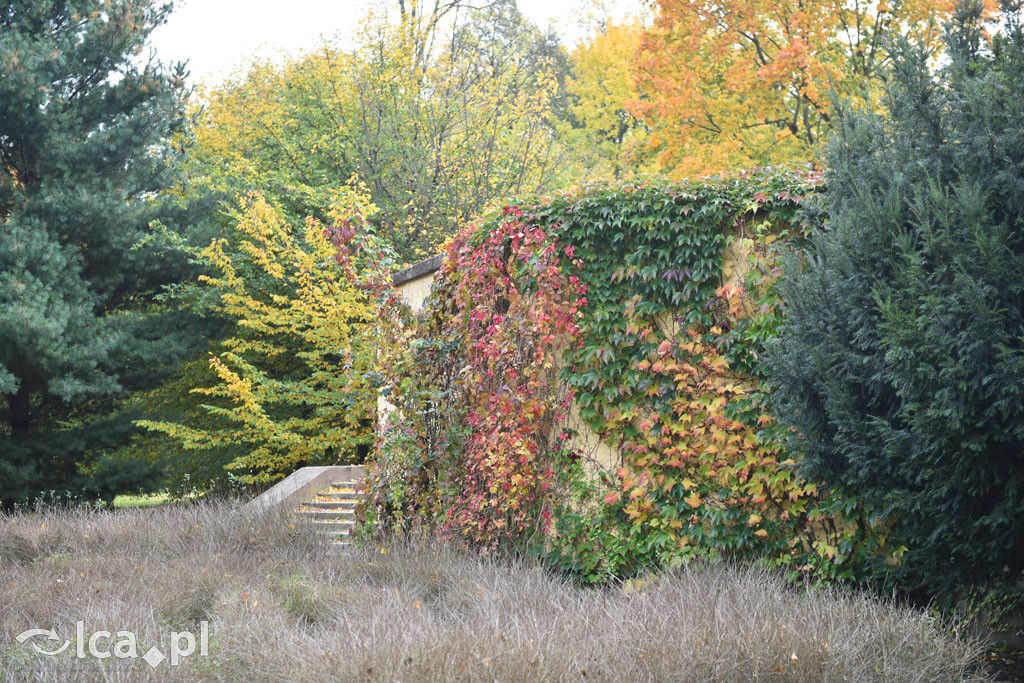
{"left": 186, "top": 51, "right": 358, "bottom": 227}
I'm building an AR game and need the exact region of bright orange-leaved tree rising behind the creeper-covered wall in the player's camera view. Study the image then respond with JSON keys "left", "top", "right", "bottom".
{"left": 633, "top": 0, "right": 951, "bottom": 176}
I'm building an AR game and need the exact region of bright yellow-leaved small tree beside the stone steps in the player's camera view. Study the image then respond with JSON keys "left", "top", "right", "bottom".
{"left": 139, "top": 189, "right": 388, "bottom": 483}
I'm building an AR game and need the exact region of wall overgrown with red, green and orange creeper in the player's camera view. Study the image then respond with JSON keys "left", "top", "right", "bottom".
{"left": 369, "top": 170, "right": 900, "bottom": 581}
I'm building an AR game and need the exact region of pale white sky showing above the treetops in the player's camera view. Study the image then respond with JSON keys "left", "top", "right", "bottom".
{"left": 152, "top": 0, "right": 640, "bottom": 82}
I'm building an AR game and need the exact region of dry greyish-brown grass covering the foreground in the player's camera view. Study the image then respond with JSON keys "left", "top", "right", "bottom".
{"left": 0, "top": 504, "right": 983, "bottom": 683}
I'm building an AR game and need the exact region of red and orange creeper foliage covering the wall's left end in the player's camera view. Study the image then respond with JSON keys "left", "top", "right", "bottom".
{"left": 372, "top": 208, "right": 587, "bottom": 547}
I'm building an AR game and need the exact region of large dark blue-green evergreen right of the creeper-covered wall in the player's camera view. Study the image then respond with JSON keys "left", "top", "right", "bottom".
{"left": 768, "top": 2, "right": 1024, "bottom": 596}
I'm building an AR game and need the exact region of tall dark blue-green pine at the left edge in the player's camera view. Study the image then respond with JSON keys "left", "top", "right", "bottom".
{"left": 0, "top": 0, "right": 191, "bottom": 504}
